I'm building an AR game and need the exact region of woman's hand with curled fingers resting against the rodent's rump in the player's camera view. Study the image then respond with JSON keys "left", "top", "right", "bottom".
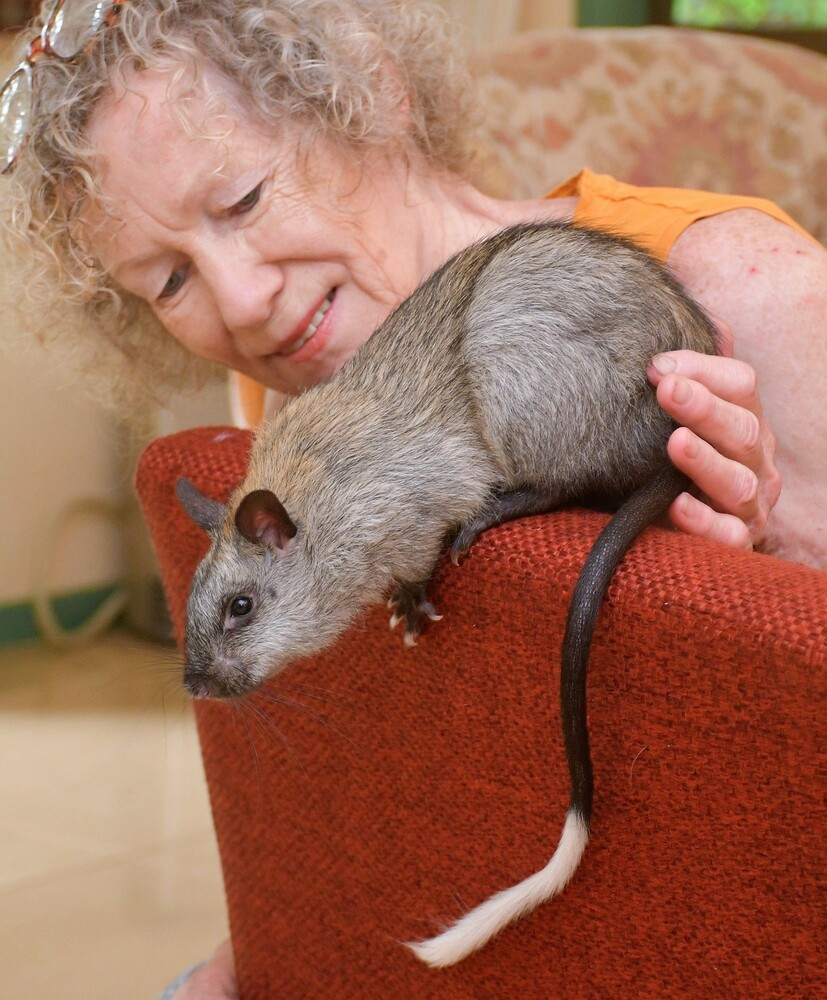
{"left": 648, "top": 329, "right": 781, "bottom": 549}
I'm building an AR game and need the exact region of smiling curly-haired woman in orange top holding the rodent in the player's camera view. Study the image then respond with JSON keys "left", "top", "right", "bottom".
{"left": 0, "top": 0, "right": 827, "bottom": 998}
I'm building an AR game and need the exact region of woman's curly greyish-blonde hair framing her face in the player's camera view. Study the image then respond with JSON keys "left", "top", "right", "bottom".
{"left": 3, "top": 0, "right": 478, "bottom": 408}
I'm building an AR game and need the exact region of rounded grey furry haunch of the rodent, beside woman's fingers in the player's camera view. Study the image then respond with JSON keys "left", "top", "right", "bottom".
{"left": 464, "top": 223, "right": 715, "bottom": 500}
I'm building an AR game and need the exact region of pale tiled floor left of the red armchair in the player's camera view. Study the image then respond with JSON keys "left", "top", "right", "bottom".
{"left": 0, "top": 634, "right": 227, "bottom": 1000}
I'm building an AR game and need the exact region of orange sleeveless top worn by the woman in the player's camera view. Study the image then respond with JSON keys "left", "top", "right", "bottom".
{"left": 230, "top": 170, "right": 821, "bottom": 427}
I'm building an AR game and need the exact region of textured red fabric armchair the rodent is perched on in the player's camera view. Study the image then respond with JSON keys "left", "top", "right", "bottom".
{"left": 137, "top": 428, "right": 827, "bottom": 1000}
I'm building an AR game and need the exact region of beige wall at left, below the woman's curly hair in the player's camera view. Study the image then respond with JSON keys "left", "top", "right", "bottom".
{"left": 0, "top": 266, "right": 230, "bottom": 608}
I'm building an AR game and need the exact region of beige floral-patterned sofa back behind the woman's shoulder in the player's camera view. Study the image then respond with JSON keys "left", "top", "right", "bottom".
{"left": 474, "top": 28, "right": 827, "bottom": 242}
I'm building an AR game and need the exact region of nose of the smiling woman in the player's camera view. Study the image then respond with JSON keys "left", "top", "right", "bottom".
{"left": 202, "top": 257, "right": 284, "bottom": 354}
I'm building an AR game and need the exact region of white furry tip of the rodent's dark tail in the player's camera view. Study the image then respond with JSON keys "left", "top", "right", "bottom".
{"left": 408, "top": 809, "right": 589, "bottom": 969}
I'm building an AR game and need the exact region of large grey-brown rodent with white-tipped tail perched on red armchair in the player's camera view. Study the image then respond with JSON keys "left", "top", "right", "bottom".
{"left": 178, "top": 223, "right": 716, "bottom": 966}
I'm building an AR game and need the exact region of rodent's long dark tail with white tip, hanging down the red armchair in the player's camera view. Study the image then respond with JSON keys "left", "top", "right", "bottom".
{"left": 408, "top": 465, "right": 688, "bottom": 968}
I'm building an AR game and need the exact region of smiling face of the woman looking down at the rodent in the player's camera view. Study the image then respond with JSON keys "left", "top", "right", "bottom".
{"left": 84, "top": 65, "right": 429, "bottom": 392}
